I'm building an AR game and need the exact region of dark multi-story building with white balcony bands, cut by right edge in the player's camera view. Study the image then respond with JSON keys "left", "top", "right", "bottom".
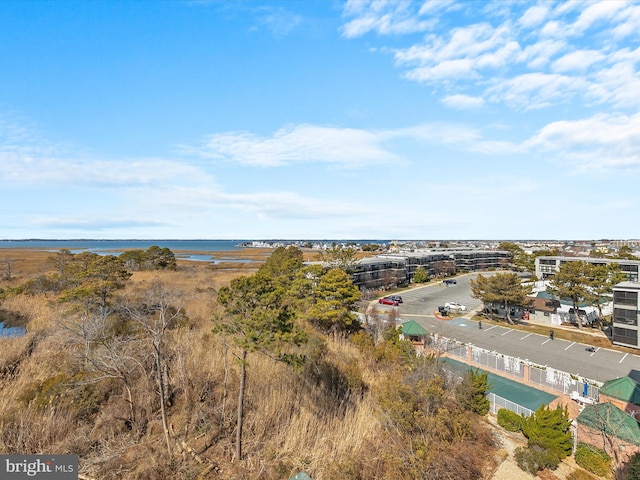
{"left": 612, "top": 281, "right": 640, "bottom": 348}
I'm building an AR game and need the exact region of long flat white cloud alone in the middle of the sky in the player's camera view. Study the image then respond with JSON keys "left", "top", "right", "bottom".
{"left": 183, "top": 125, "right": 398, "bottom": 167}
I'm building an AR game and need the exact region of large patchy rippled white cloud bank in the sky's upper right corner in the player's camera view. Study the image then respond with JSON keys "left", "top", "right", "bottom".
{"left": 344, "top": 1, "right": 640, "bottom": 110}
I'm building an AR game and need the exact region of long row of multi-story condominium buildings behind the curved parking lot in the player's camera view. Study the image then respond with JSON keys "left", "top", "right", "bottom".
{"left": 351, "top": 250, "right": 511, "bottom": 290}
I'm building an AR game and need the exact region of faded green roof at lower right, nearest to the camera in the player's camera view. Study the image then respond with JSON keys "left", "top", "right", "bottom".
{"left": 576, "top": 403, "right": 640, "bottom": 445}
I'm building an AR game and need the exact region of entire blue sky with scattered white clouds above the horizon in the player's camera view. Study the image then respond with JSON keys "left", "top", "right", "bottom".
{"left": 0, "top": 0, "right": 640, "bottom": 239}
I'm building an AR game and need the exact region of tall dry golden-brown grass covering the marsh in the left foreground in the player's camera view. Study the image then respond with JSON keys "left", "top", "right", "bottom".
{"left": 0, "top": 249, "right": 498, "bottom": 480}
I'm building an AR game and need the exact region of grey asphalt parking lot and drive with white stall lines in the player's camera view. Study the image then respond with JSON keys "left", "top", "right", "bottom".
{"left": 378, "top": 276, "right": 640, "bottom": 382}
